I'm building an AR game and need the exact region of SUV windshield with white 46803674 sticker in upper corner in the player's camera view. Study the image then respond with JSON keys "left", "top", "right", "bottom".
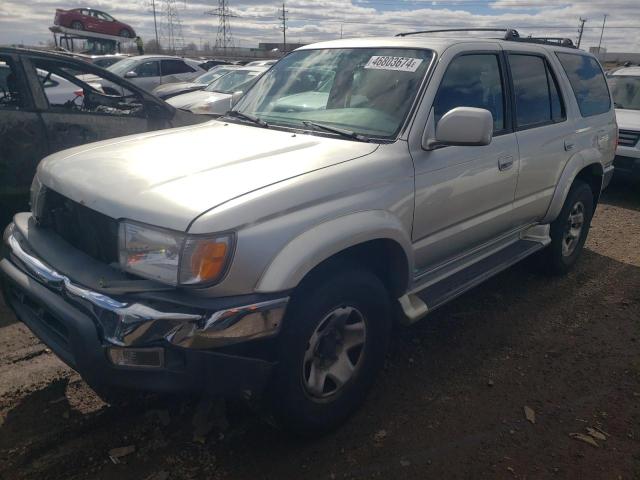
{"left": 236, "top": 48, "right": 433, "bottom": 139}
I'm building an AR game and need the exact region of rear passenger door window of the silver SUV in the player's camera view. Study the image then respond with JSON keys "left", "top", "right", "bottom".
{"left": 509, "top": 54, "right": 566, "bottom": 128}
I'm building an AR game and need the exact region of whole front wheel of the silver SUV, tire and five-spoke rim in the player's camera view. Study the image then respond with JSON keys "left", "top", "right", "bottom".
{"left": 271, "top": 266, "right": 391, "bottom": 435}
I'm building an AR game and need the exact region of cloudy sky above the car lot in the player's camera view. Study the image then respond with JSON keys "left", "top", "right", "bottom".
{"left": 0, "top": 0, "right": 640, "bottom": 52}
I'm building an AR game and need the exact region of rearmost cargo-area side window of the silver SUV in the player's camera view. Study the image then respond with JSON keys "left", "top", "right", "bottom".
{"left": 556, "top": 53, "right": 611, "bottom": 117}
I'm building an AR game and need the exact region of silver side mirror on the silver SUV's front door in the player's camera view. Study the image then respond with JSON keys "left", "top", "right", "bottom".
{"left": 423, "top": 107, "right": 493, "bottom": 150}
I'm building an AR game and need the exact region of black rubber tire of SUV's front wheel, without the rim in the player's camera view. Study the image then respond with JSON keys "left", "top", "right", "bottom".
{"left": 270, "top": 266, "right": 392, "bottom": 437}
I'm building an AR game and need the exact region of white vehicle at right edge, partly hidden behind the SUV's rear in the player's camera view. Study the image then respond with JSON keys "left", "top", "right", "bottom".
{"left": 607, "top": 66, "right": 640, "bottom": 181}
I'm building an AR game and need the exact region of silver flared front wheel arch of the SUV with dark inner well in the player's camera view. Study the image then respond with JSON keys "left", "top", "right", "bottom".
{"left": 256, "top": 211, "right": 413, "bottom": 298}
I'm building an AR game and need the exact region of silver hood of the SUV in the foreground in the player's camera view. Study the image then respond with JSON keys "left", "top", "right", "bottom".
{"left": 38, "top": 121, "right": 377, "bottom": 231}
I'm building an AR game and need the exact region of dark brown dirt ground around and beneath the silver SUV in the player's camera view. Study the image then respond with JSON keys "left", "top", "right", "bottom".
{"left": 0, "top": 181, "right": 640, "bottom": 480}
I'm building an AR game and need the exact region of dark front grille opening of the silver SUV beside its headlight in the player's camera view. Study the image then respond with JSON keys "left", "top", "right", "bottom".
{"left": 38, "top": 189, "right": 118, "bottom": 264}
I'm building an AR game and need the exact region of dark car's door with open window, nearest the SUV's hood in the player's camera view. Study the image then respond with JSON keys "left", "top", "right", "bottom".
{"left": 25, "top": 57, "right": 158, "bottom": 152}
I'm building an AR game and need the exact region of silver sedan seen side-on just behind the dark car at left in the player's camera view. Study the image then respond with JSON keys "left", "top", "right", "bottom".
{"left": 108, "top": 55, "right": 206, "bottom": 92}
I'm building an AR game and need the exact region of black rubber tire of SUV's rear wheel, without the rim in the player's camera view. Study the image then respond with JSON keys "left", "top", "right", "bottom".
{"left": 541, "top": 180, "right": 594, "bottom": 275}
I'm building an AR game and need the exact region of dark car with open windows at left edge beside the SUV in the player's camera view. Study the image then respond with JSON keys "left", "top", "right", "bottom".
{"left": 0, "top": 48, "right": 206, "bottom": 230}
